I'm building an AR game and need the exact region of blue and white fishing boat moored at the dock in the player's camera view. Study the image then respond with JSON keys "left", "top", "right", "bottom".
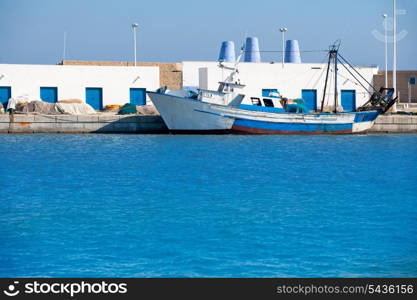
{"left": 148, "top": 43, "right": 397, "bottom": 134}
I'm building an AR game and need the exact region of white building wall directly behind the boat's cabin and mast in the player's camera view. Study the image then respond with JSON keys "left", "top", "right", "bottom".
{"left": 183, "top": 61, "right": 378, "bottom": 108}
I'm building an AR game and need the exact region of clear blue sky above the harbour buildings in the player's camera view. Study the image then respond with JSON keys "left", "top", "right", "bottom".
{"left": 0, "top": 0, "right": 417, "bottom": 70}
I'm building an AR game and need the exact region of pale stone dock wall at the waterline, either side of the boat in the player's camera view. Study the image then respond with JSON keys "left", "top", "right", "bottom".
{"left": 0, "top": 114, "right": 417, "bottom": 133}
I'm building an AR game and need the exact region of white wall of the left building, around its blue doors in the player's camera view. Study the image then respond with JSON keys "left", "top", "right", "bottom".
{"left": 0, "top": 64, "right": 159, "bottom": 106}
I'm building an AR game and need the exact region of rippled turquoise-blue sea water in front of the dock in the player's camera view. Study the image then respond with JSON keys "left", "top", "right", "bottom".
{"left": 0, "top": 134, "right": 417, "bottom": 277}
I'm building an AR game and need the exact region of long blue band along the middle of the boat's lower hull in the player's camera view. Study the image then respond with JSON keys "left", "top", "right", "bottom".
{"left": 233, "top": 119, "right": 352, "bottom": 133}
